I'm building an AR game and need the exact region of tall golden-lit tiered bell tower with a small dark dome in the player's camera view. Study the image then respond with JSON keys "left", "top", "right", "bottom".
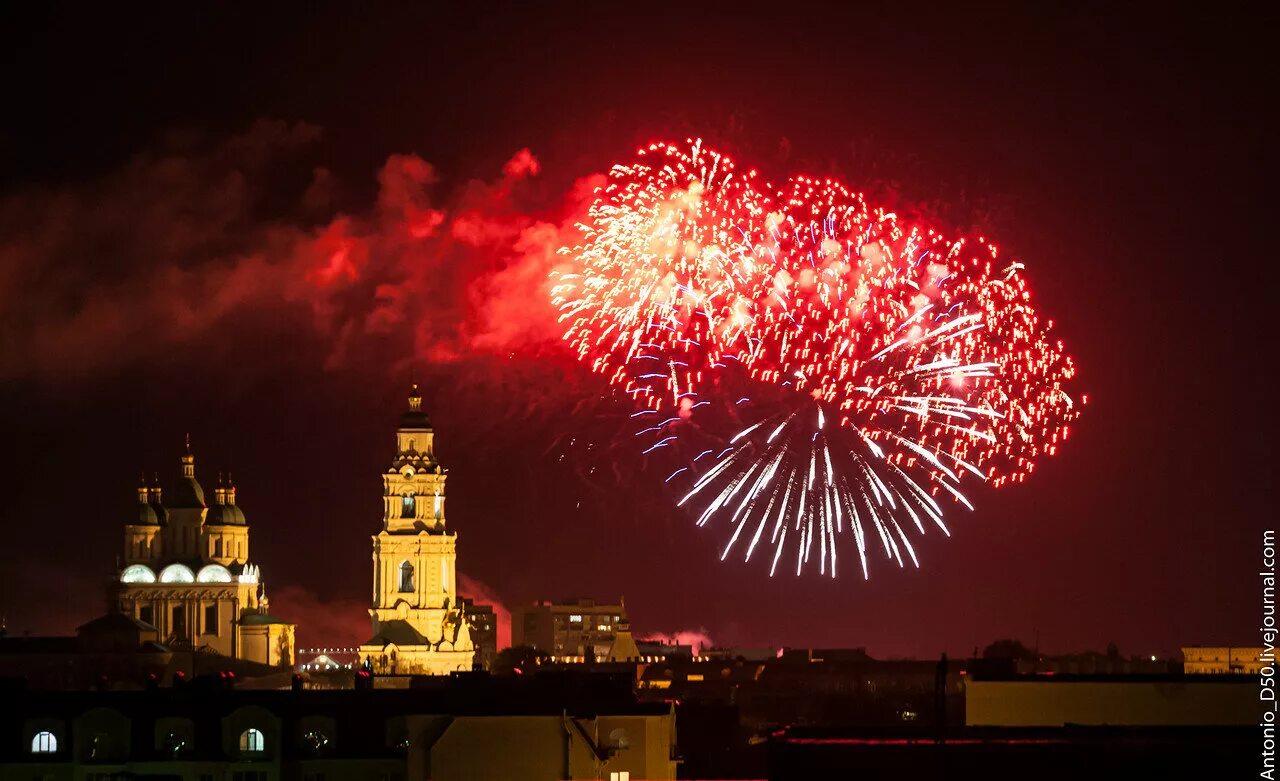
{"left": 360, "top": 385, "right": 475, "bottom": 675}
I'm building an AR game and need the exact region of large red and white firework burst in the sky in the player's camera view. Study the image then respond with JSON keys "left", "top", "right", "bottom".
{"left": 552, "top": 141, "right": 1084, "bottom": 577}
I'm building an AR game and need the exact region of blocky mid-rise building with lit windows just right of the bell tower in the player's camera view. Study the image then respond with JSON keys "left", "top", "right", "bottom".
{"left": 511, "top": 599, "right": 627, "bottom": 658}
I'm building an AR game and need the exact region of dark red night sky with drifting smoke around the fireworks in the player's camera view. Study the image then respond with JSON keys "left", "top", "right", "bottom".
{"left": 0, "top": 3, "right": 1274, "bottom": 657}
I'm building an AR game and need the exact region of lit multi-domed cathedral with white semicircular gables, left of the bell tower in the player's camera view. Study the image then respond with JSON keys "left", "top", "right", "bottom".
{"left": 111, "top": 439, "right": 294, "bottom": 666}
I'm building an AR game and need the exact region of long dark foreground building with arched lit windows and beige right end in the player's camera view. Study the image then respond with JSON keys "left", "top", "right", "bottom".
{"left": 0, "top": 673, "right": 676, "bottom": 781}
